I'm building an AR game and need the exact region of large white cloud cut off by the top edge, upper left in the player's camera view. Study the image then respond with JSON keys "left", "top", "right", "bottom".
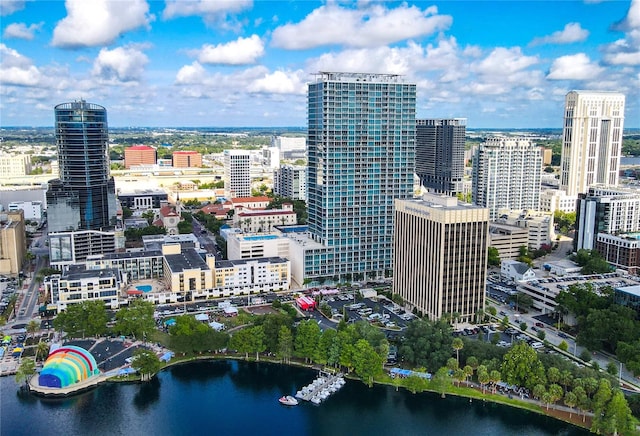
{"left": 52, "top": 0, "right": 154, "bottom": 48}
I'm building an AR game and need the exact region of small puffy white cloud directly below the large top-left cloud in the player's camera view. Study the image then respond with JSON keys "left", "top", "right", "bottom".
{"left": 92, "top": 47, "right": 149, "bottom": 82}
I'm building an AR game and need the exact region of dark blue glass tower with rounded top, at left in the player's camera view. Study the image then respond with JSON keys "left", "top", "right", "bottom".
{"left": 47, "top": 100, "right": 116, "bottom": 232}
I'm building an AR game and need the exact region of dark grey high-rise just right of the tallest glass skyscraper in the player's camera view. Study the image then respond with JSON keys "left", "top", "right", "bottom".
{"left": 416, "top": 118, "right": 467, "bottom": 195}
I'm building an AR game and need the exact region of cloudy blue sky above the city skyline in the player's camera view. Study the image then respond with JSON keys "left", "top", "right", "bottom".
{"left": 0, "top": 0, "right": 640, "bottom": 128}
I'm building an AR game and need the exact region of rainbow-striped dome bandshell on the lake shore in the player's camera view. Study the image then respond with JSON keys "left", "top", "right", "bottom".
{"left": 38, "top": 345, "right": 100, "bottom": 388}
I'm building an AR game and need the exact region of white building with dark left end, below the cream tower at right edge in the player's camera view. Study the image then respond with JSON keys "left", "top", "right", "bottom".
{"left": 574, "top": 186, "right": 640, "bottom": 250}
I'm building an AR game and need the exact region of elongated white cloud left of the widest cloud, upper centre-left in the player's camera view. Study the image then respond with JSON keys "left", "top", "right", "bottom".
{"left": 192, "top": 35, "right": 264, "bottom": 65}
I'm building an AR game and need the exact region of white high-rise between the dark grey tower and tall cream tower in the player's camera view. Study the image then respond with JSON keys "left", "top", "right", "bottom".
{"left": 471, "top": 138, "right": 542, "bottom": 220}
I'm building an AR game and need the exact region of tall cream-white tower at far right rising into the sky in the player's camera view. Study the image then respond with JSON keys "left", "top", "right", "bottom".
{"left": 560, "top": 91, "right": 625, "bottom": 196}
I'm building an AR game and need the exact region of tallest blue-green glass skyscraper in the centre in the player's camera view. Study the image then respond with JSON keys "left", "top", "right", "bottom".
{"left": 304, "top": 72, "right": 416, "bottom": 280}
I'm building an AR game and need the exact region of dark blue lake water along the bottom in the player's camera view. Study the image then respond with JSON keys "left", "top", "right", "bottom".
{"left": 0, "top": 361, "right": 588, "bottom": 436}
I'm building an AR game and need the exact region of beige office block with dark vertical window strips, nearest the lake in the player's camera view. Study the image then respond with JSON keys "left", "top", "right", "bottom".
{"left": 393, "top": 194, "right": 489, "bottom": 322}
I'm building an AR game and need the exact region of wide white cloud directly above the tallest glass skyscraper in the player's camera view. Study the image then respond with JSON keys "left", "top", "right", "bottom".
{"left": 272, "top": 3, "right": 452, "bottom": 50}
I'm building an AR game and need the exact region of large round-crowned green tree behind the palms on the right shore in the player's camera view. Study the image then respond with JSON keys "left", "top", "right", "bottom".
{"left": 501, "top": 342, "right": 546, "bottom": 389}
